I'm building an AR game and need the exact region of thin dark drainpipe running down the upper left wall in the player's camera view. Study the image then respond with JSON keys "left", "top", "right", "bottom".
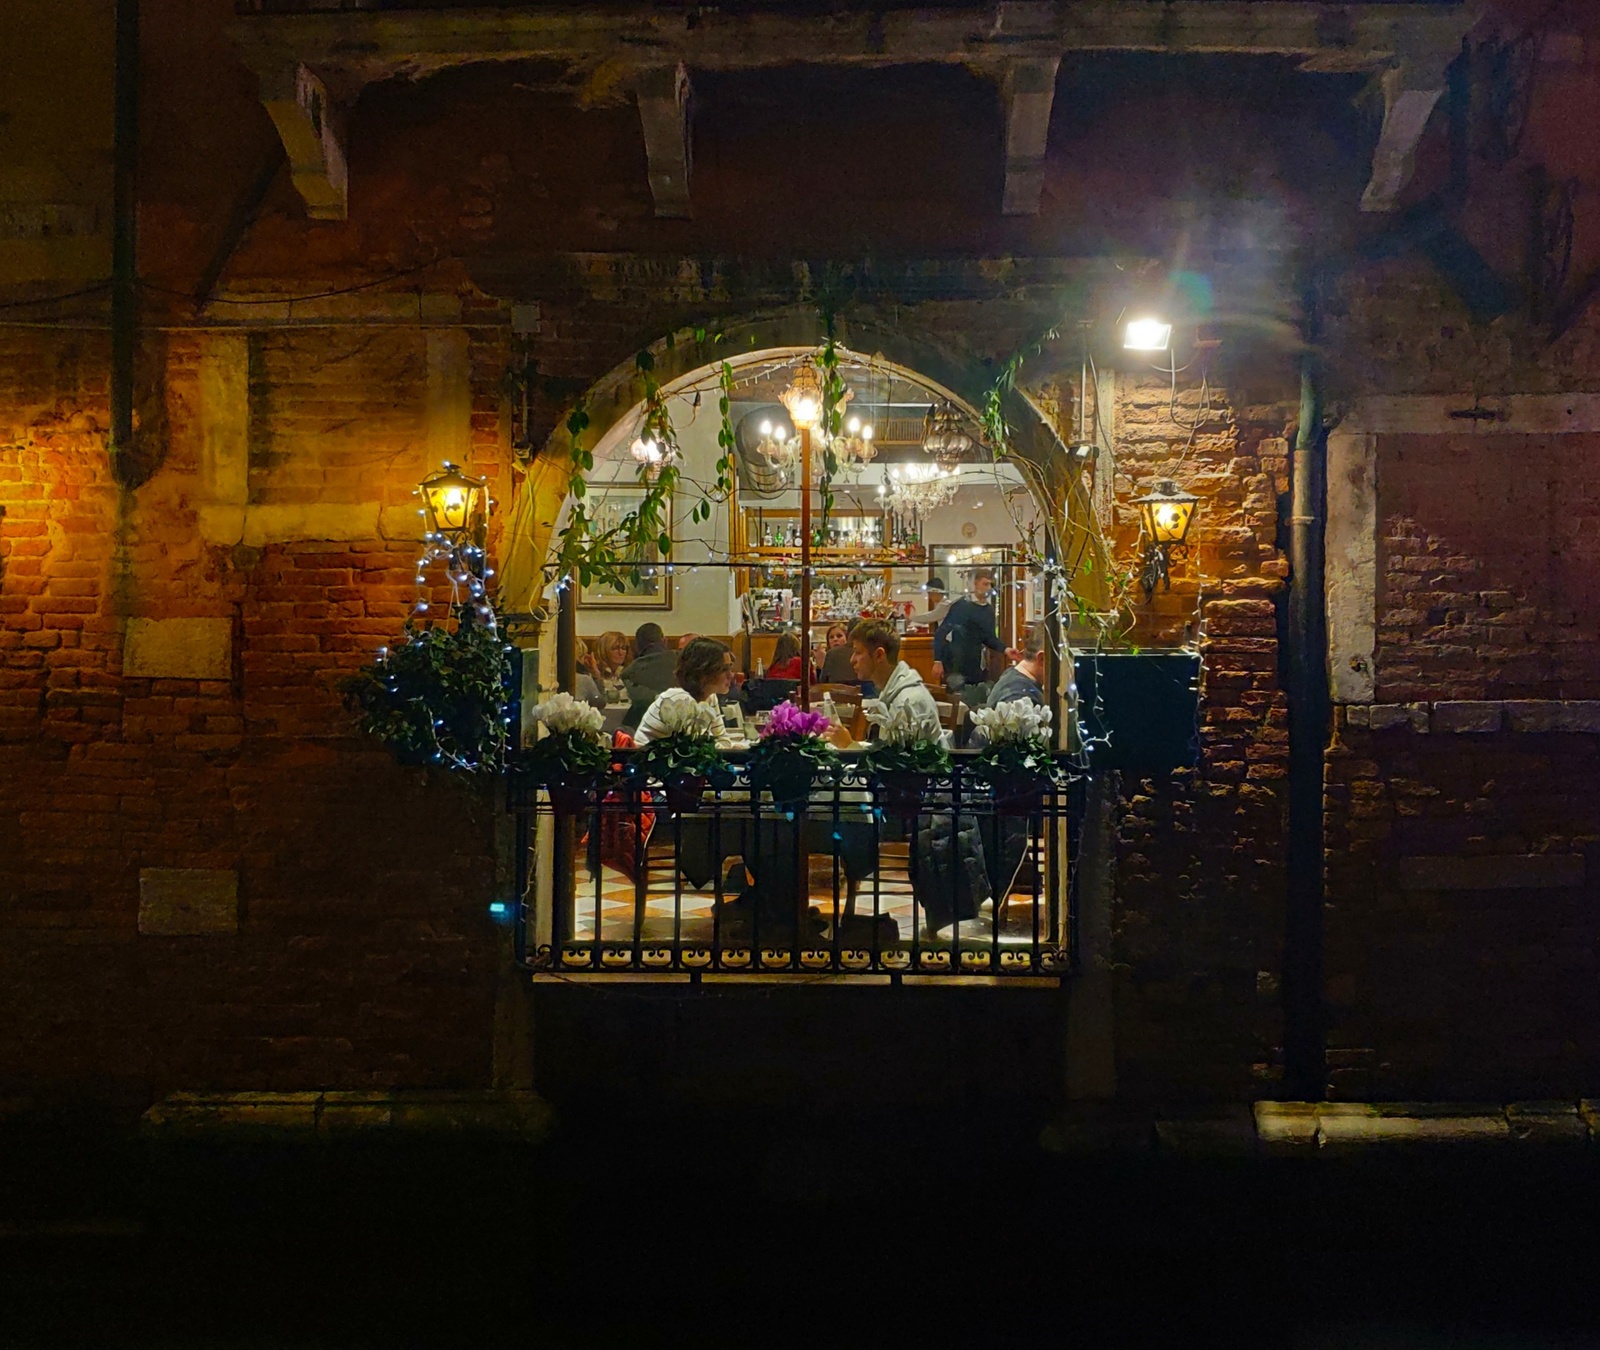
{"left": 110, "top": 0, "right": 139, "bottom": 478}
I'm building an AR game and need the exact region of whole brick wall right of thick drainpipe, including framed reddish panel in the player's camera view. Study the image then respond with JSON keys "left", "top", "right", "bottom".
{"left": 1325, "top": 261, "right": 1600, "bottom": 1099}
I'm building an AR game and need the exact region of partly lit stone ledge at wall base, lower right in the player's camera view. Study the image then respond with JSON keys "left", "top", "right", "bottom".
{"left": 1040, "top": 1099, "right": 1600, "bottom": 1158}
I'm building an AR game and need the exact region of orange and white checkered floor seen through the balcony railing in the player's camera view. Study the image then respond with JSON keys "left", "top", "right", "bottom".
{"left": 568, "top": 843, "right": 1043, "bottom": 945}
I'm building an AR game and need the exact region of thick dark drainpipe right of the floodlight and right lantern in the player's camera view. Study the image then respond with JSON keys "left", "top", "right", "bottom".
{"left": 1283, "top": 321, "right": 1330, "bottom": 1100}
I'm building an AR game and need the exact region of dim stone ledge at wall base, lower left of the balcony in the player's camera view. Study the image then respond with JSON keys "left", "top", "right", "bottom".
{"left": 139, "top": 1091, "right": 554, "bottom": 1144}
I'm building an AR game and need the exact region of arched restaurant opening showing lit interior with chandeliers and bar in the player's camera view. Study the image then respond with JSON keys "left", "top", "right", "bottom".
{"left": 512, "top": 324, "right": 1075, "bottom": 977}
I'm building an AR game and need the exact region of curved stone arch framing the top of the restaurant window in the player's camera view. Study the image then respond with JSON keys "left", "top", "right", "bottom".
{"left": 504, "top": 306, "right": 1098, "bottom": 609}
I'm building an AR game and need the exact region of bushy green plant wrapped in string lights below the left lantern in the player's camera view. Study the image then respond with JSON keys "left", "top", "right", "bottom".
{"left": 339, "top": 605, "right": 510, "bottom": 776}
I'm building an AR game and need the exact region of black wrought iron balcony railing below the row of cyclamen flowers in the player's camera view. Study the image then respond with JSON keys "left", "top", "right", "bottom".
{"left": 509, "top": 750, "right": 1082, "bottom": 981}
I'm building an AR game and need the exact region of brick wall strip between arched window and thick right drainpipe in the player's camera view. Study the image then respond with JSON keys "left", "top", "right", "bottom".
{"left": 1112, "top": 379, "right": 1293, "bottom": 1100}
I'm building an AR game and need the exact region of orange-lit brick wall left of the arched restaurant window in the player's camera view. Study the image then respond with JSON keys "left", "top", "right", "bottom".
{"left": 0, "top": 331, "right": 504, "bottom": 1097}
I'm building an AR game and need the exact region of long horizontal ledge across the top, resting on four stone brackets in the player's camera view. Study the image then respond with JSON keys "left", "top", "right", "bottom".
{"left": 232, "top": 0, "right": 1474, "bottom": 88}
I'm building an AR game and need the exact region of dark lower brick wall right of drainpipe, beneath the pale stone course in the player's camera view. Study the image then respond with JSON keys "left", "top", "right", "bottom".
{"left": 1325, "top": 716, "right": 1600, "bottom": 1100}
